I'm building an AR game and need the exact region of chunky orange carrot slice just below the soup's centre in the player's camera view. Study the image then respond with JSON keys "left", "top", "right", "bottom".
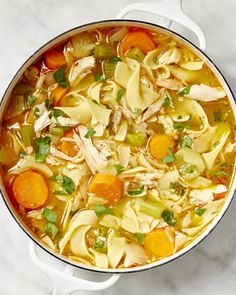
{"left": 89, "top": 173, "right": 124, "bottom": 204}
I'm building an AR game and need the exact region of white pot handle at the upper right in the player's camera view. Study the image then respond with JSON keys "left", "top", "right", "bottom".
{"left": 116, "top": 0, "right": 206, "bottom": 51}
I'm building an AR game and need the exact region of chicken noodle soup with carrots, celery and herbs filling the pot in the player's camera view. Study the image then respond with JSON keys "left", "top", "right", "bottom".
{"left": 0, "top": 26, "right": 235, "bottom": 268}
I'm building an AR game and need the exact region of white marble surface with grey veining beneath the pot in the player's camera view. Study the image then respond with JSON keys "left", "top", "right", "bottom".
{"left": 0, "top": 0, "right": 236, "bottom": 295}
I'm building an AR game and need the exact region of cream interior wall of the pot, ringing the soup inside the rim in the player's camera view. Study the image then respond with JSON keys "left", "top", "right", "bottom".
{"left": 0, "top": 20, "right": 236, "bottom": 273}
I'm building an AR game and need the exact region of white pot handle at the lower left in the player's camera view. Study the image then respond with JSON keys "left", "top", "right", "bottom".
{"left": 29, "top": 241, "right": 120, "bottom": 295}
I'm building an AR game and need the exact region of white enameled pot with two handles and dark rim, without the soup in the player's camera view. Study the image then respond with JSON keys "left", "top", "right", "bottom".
{"left": 0, "top": 0, "right": 236, "bottom": 294}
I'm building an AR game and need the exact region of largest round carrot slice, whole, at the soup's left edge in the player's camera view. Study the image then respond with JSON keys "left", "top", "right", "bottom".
{"left": 12, "top": 170, "right": 48, "bottom": 209}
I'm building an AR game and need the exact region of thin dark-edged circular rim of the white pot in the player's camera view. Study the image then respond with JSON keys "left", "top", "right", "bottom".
{"left": 0, "top": 19, "right": 236, "bottom": 274}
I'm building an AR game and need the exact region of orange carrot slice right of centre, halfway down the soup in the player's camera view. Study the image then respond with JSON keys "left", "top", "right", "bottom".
{"left": 149, "top": 134, "right": 175, "bottom": 160}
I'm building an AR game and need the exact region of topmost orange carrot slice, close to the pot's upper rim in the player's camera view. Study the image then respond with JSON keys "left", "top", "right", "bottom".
{"left": 120, "top": 29, "right": 156, "bottom": 54}
